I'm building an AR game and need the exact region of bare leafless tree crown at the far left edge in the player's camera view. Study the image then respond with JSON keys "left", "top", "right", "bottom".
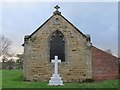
{"left": 0, "top": 35, "right": 11, "bottom": 55}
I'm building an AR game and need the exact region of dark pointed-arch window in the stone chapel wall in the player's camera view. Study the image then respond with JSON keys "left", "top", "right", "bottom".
{"left": 50, "top": 30, "right": 65, "bottom": 62}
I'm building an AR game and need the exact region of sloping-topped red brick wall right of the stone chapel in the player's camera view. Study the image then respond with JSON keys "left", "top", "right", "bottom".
{"left": 92, "top": 46, "right": 118, "bottom": 80}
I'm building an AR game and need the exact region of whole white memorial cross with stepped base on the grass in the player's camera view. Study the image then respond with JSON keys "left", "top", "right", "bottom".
{"left": 48, "top": 56, "right": 64, "bottom": 86}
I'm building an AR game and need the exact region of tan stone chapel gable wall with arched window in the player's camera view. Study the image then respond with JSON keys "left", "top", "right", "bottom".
{"left": 23, "top": 6, "right": 118, "bottom": 82}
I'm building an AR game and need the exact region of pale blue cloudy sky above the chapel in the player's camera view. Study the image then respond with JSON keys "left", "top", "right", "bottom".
{"left": 1, "top": 2, "right": 118, "bottom": 55}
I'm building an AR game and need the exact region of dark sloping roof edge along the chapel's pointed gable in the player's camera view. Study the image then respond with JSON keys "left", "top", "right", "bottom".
{"left": 27, "top": 12, "right": 87, "bottom": 38}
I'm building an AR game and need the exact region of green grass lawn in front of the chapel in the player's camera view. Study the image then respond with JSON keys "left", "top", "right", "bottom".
{"left": 2, "top": 70, "right": 118, "bottom": 88}
